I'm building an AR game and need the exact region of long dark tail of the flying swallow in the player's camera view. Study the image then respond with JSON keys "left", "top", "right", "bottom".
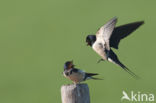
{"left": 108, "top": 50, "right": 140, "bottom": 79}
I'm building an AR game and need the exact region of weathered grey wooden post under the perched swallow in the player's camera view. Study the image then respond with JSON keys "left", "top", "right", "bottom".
{"left": 61, "top": 84, "right": 90, "bottom": 103}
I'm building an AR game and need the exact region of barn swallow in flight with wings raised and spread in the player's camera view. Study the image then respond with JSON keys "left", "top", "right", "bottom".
{"left": 86, "top": 17, "right": 144, "bottom": 77}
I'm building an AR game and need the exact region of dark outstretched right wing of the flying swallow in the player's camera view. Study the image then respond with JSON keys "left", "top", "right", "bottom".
{"left": 110, "top": 21, "right": 144, "bottom": 49}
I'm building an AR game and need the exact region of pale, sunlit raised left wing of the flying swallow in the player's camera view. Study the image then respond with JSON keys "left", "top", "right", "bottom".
{"left": 96, "top": 17, "right": 117, "bottom": 50}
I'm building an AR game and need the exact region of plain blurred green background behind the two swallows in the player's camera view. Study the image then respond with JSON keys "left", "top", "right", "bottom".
{"left": 0, "top": 0, "right": 156, "bottom": 103}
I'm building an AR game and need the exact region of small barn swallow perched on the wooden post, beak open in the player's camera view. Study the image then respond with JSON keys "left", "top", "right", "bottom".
{"left": 63, "top": 61, "right": 100, "bottom": 84}
